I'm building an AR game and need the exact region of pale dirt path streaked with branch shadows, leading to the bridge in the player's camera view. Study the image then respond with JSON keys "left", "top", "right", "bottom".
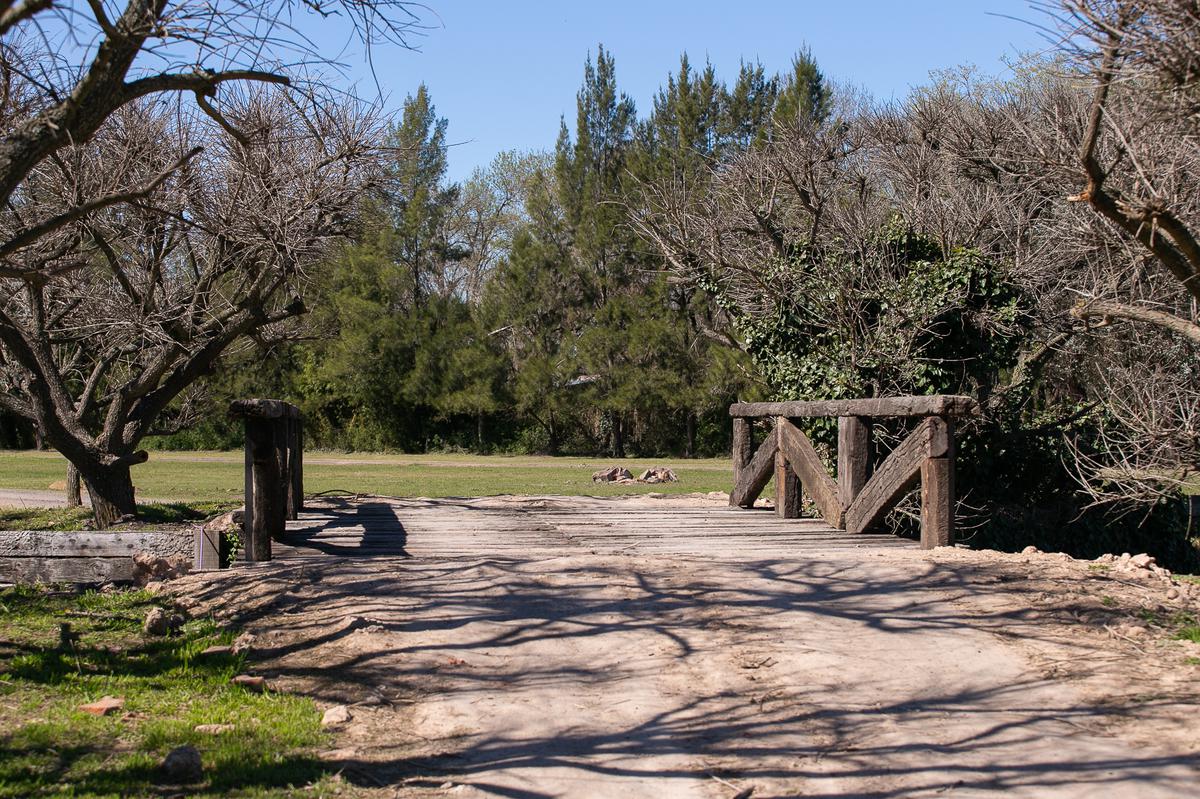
{"left": 174, "top": 494, "right": 1200, "bottom": 799}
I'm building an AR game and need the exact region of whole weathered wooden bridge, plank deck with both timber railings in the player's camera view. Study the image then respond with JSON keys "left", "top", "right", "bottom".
{"left": 218, "top": 396, "right": 976, "bottom": 560}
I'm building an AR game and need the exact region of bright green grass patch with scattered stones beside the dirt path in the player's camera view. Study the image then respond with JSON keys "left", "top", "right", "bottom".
{"left": 0, "top": 588, "right": 348, "bottom": 799}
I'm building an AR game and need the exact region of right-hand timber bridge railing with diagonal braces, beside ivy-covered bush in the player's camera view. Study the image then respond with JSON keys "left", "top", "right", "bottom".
{"left": 730, "top": 395, "right": 978, "bottom": 549}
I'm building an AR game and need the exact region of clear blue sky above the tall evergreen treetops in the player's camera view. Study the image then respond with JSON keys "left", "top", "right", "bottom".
{"left": 307, "top": 0, "right": 1045, "bottom": 180}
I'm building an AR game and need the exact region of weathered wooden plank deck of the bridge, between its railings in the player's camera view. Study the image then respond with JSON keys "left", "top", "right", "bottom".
{"left": 272, "top": 497, "right": 917, "bottom": 559}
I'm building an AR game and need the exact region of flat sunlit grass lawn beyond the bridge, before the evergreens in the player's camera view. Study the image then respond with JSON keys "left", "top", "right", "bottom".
{"left": 0, "top": 443, "right": 733, "bottom": 501}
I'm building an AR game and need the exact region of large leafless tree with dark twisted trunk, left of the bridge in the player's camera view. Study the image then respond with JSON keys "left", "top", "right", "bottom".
{"left": 0, "top": 0, "right": 418, "bottom": 525}
